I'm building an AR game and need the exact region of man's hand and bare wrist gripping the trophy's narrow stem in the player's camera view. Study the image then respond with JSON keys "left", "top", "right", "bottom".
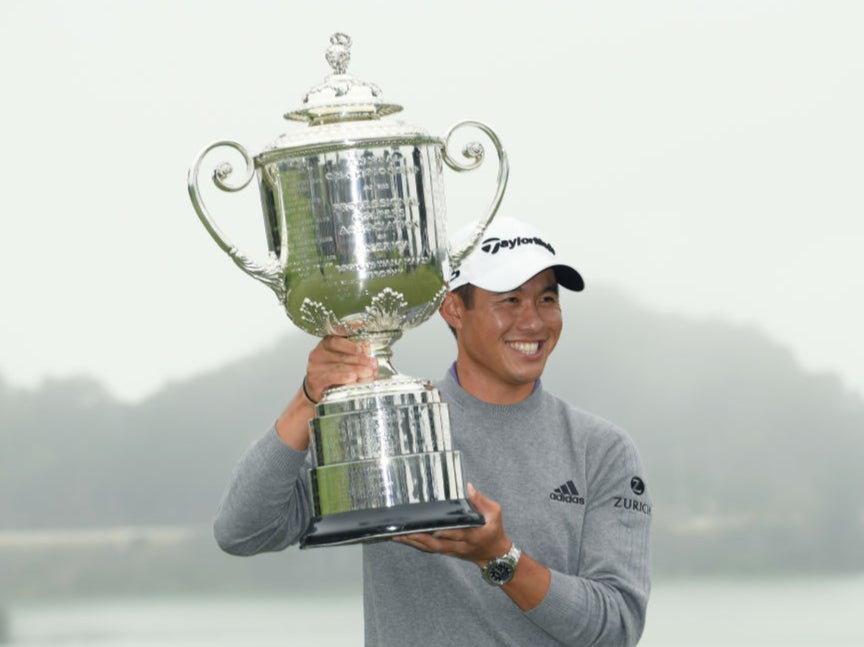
{"left": 276, "top": 336, "right": 378, "bottom": 451}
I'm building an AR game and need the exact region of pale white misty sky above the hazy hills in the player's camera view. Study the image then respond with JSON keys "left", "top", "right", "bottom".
{"left": 0, "top": 0, "right": 864, "bottom": 399}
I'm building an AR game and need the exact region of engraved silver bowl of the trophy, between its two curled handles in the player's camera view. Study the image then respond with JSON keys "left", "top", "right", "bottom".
{"left": 259, "top": 145, "right": 446, "bottom": 336}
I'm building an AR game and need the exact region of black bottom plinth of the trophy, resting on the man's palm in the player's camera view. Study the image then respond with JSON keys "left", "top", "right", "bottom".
{"left": 300, "top": 499, "right": 485, "bottom": 548}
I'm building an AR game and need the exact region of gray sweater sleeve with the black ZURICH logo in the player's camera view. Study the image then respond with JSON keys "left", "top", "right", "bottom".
{"left": 526, "top": 432, "right": 651, "bottom": 647}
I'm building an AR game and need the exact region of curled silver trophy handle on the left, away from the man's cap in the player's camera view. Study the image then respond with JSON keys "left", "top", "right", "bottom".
{"left": 187, "top": 140, "right": 285, "bottom": 300}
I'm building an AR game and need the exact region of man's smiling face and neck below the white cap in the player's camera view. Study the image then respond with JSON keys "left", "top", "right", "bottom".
{"left": 448, "top": 269, "right": 562, "bottom": 403}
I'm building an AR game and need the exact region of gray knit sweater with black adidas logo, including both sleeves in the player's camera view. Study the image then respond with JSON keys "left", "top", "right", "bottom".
{"left": 214, "top": 373, "right": 652, "bottom": 647}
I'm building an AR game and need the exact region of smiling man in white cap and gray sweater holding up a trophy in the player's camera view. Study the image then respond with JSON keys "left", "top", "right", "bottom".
{"left": 215, "top": 217, "right": 651, "bottom": 647}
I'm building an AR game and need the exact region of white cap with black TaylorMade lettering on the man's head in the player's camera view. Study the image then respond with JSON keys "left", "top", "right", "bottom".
{"left": 450, "top": 216, "right": 585, "bottom": 292}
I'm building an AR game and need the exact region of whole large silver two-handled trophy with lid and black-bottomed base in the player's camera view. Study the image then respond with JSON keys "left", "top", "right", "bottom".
{"left": 188, "top": 34, "right": 509, "bottom": 547}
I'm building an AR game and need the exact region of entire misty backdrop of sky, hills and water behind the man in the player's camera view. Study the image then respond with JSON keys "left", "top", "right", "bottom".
{"left": 0, "top": 0, "right": 864, "bottom": 647}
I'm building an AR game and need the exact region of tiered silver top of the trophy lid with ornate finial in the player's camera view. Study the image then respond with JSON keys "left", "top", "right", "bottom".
{"left": 284, "top": 33, "right": 402, "bottom": 126}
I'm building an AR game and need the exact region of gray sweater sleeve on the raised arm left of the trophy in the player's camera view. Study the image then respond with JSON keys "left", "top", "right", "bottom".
{"left": 213, "top": 427, "right": 311, "bottom": 555}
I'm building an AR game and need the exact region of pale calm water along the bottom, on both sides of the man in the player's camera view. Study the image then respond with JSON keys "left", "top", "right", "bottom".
{"left": 7, "top": 576, "right": 864, "bottom": 647}
